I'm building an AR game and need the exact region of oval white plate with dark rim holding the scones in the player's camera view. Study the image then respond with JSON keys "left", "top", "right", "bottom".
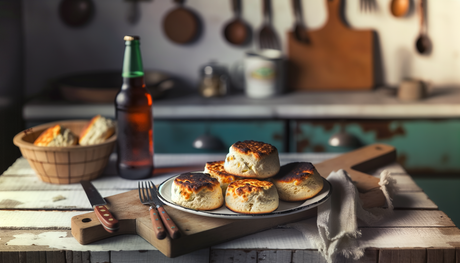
{"left": 158, "top": 175, "right": 332, "bottom": 219}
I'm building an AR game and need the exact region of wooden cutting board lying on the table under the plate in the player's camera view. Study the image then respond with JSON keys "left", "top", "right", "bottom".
{"left": 71, "top": 144, "right": 396, "bottom": 257}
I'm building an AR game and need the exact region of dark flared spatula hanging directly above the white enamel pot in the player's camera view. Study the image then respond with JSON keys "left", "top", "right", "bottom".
{"left": 259, "top": 0, "right": 281, "bottom": 50}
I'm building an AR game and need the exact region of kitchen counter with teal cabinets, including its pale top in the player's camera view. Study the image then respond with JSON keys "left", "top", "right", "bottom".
{"left": 19, "top": 88, "right": 460, "bottom": 175}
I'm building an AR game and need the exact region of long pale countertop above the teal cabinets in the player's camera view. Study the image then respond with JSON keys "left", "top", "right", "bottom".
{"left": 23, "top": 88, "right": 460, "bottom": 121}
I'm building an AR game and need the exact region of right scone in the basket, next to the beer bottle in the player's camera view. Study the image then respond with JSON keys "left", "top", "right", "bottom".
{"left": 79, "top": 115, "right": 115, "bottom": 145}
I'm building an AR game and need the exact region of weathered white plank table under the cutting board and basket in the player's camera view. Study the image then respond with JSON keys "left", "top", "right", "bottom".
{"left": 0, "top": 153, "right": 460, "bottom": 263}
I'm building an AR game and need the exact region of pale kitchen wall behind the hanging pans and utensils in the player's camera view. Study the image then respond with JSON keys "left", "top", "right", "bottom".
{"left": 22, "top": 0, "right": 460, "bottom": 96}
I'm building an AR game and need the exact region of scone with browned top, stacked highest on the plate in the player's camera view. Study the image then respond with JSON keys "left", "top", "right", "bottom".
{"left": 224, "top": 141, "right": 280, "bottom": 179}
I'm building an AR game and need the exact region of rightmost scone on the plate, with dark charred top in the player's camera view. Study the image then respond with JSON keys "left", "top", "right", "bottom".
{"left": 271, "top": 162, "right": 323, "bottom": 201}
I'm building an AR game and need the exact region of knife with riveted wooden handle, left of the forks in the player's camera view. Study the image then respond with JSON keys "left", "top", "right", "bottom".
{"left": 80, "top": 181, "right": 118, "bottom": 233}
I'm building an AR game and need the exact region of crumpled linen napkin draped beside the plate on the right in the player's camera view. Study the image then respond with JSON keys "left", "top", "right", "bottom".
{"left": 289, "top": 169, "right": 396, "bottom": 263}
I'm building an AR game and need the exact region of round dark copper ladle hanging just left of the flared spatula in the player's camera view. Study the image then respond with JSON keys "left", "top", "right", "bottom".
{"left": 224, "top": 0, "right": 251, "bottom": 46}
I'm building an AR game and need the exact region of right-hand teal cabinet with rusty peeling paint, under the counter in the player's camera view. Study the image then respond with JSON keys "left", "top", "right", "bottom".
{"left": 290, "top": 119, "right": 460, "bottom": 174}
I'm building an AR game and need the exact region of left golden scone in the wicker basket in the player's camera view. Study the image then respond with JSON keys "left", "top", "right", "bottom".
{"left": 34, "top": 124, "right": 78, "bottom": 147}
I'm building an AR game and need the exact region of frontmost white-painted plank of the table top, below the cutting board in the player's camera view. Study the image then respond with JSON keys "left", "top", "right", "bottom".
{"left": 0, "top": 227, "right": 460, "bottom": 255}
